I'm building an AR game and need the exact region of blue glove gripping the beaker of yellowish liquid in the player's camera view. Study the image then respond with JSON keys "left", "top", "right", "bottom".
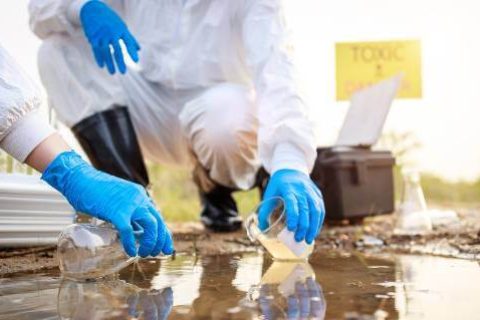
{"left": 258, "top": 169, "right": 325, "bottom": 244}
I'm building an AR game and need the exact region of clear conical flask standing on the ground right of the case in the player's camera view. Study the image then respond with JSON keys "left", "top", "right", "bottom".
{"left": 394, "top": 170, "right": 432, "bottom": 235}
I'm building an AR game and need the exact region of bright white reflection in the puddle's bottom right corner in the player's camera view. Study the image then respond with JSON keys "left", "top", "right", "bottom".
{"left": 392, "top": 255, "right": 480, "bottom": 319}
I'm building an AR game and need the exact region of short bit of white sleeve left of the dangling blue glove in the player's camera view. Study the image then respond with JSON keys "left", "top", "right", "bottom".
{"left": 28, "top": 0, "right": 89, "bottom": 39}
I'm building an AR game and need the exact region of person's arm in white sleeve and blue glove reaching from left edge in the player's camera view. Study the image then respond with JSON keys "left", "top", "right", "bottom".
{"left": 0, "top": 46, "right": 174, "bottom": 257}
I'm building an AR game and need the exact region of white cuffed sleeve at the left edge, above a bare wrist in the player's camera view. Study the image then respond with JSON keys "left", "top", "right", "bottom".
{"left": 0, "top": 46, "right": 54, "bottom": 162}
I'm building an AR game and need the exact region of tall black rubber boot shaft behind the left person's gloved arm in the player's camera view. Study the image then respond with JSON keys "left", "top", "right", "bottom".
{"left": 72, "top": 107, "right": 150, "bottom": 187}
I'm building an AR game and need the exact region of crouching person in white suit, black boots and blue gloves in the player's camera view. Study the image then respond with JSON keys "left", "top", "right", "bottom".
{"left": 29, "top": 0, "right": 325, "bottom": 243}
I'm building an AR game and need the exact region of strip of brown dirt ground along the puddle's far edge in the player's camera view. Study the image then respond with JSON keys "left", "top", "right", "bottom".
{"left": 0, "top": 209, "right": 480, "bottom": 277}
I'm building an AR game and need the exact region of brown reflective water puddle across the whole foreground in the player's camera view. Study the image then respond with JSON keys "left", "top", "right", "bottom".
{"left": 0, "top": 253, "right": 480, "bottom": 320}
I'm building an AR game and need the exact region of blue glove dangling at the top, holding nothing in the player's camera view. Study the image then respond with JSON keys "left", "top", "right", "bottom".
{"left": 80, "top": 0, "right": 140, "bottom": 74}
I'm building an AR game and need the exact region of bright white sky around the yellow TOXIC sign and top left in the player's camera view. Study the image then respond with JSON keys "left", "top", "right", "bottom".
{"left": 0, "top": 0, "right": 480, "bottom": 180}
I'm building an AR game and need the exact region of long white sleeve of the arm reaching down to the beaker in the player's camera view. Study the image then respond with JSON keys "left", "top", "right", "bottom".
{"left": 242, "top": 0, "right": 316, "bottom": 173}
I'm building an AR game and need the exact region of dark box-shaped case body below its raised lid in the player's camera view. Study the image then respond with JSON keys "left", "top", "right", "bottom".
{"left": 311, "top": 147, "right": 395, "bottom": 220}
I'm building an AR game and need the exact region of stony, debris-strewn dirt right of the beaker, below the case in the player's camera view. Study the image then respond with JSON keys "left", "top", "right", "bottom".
{"left": 316, "top": 210, "right": 480, "bottom": 260}
